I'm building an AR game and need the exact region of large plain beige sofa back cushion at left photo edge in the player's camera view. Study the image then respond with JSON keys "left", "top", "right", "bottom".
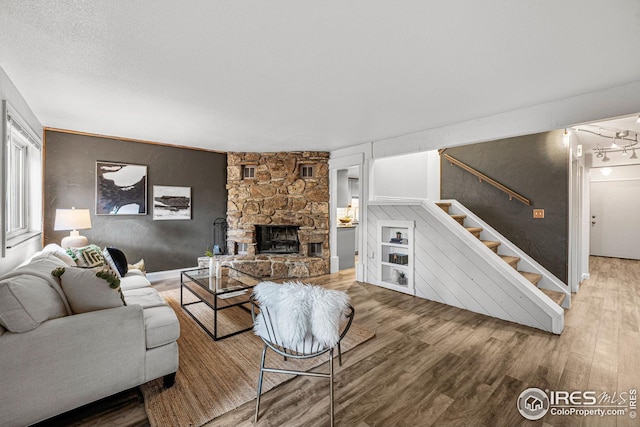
{"left": 0, "top": 274, "right": 67, "bottom": 332}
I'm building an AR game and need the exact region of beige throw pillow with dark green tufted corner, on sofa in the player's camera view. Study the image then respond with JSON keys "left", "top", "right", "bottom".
{"left": 51, "top": 267, "right": 127, "bottom": 314}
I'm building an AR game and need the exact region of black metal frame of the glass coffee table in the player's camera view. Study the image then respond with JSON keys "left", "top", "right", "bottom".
{"left": 180, "top": 266, "right": 261, "bottom": 341}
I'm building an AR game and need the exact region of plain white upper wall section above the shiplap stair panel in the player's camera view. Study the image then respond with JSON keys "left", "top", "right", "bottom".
{"left": 373, "top": 150, "right": 440, "bottom": 200}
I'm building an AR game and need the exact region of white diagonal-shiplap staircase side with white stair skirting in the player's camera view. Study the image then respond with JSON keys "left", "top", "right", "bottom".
{"left": 366, "top": 199, "right": 571, "bottom": 334}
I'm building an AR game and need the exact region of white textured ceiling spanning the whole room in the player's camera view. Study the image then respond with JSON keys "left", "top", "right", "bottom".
{"left": 0, "top": 0, "right": 640, "bottom": 151}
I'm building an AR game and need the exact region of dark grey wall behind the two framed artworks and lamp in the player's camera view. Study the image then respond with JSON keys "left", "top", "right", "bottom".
{"left": 44, "top": 131, "right": 227, "bottom": 272}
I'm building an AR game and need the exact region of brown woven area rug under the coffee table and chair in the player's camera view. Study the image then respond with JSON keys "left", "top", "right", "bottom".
{"left": 140, "top": 289, "right": 374, "bottom": 427}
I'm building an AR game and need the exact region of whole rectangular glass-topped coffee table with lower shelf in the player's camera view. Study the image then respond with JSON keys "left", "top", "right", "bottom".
{"left": 180, "top": 266, "right": 262, "bottom": 341}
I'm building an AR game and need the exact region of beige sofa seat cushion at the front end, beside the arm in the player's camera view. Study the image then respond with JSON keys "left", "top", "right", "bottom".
{"left": 124, "top": 288, "right": 180, "bottom": 348}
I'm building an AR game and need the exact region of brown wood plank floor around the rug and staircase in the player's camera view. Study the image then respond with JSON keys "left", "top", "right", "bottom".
{"left": 42, "top": 257, "right": 640, "bottom": 427}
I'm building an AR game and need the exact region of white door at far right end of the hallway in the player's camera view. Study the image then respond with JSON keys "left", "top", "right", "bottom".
{"left": 590, "top": 180, "right": 640, "bottom": 259}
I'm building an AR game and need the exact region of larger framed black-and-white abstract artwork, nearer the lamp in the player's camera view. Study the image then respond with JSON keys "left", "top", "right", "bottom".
{"left": 96, "top": 162, "right": 147, "bottom": 215}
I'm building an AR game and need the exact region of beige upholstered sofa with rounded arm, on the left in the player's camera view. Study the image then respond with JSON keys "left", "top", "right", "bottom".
{"left": 0, "top": 245, "right": 180, "bottom": 426}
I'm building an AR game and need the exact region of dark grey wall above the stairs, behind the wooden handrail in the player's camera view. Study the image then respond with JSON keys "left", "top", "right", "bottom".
{"left": 441, "top": 131, "right": 569, "bottom": 283}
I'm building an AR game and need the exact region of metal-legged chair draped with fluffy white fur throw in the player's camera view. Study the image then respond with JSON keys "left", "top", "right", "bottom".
{"left": 251, "top": 282, "right": 355, "bottom": 426}
